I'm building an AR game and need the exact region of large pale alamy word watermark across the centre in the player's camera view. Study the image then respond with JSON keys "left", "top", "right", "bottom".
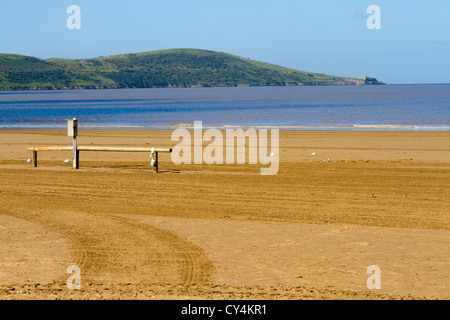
{"left": 171, "top": 121, "right": 280, "bottom": 175}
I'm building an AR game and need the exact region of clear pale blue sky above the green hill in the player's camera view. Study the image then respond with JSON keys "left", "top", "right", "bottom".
{"left": 0, "top": 0, "right": 450, "bottom": 84}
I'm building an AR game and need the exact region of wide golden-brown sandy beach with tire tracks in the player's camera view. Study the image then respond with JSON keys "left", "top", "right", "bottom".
{"left": 0, "top": 129, "right": 450, "bottom": 300}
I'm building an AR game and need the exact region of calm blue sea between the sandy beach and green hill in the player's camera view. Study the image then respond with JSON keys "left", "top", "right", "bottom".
{"left": 0, "top": 84, "right": 450, "bottom": 131}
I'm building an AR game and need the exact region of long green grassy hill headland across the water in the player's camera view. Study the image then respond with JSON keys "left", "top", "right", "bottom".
{"left": 0, "top": 49, "right": 382, "bottom": 90}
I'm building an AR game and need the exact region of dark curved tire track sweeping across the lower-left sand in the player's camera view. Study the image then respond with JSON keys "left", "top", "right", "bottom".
{"left": 2, "top": 208, "right": 212, "bottom": 291}
